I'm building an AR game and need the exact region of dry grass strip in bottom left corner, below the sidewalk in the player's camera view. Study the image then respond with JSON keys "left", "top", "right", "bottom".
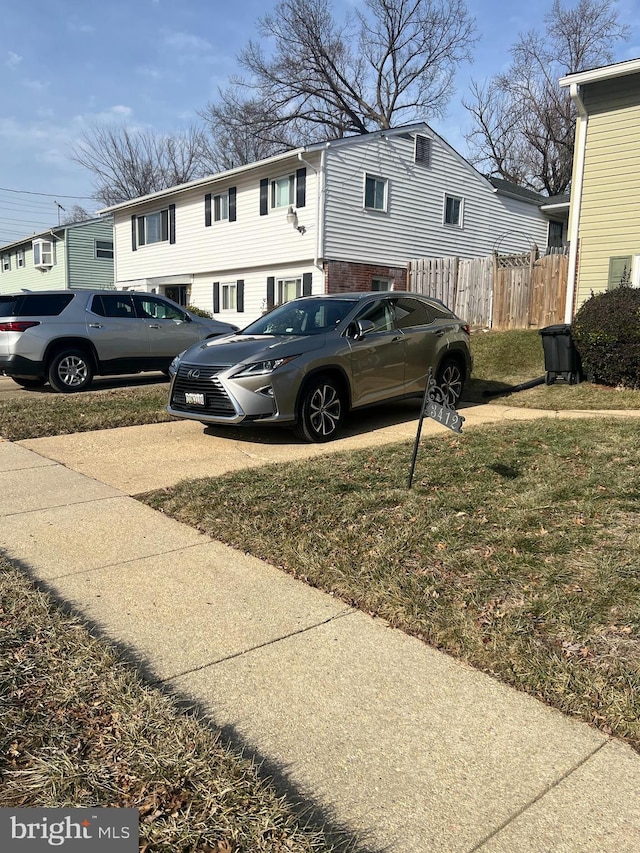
{"left": 0, "top": 558, "right": 338, "bottom": 853}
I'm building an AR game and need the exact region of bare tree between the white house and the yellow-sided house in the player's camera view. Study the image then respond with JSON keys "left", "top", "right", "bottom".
{"left": 464, "top": 0, "right": 629, "bottom": 195}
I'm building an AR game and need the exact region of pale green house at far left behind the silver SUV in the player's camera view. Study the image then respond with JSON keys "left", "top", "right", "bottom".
{"left": 0, "top": 217, "right": 114, "bottom": 293}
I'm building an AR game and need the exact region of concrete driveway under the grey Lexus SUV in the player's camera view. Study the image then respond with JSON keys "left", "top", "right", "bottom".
{"left": 18, "top": 401, "right": 568, "bottom": 495}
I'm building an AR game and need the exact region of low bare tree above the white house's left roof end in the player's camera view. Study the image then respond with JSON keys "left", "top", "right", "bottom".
{"left": 72, "top": 125, "right": 211, "bottom": 205}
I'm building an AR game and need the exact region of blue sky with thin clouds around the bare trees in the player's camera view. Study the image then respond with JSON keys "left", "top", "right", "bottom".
{"left": 0, "top": 0, "right": 640, "bottom": 245}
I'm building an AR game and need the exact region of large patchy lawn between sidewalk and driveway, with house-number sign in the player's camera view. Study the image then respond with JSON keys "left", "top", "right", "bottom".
{"left": 141, "top": 419, "right": 640, "bottom": 749}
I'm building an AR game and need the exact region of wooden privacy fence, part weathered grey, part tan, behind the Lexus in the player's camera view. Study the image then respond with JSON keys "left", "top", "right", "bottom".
{"left": 409, "top": 250, "right": 569, "bottom": 329}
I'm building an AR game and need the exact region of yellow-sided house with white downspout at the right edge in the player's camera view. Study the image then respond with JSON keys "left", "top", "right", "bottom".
{"left": 560, "top": 59, "right": 640, "bottom": 323}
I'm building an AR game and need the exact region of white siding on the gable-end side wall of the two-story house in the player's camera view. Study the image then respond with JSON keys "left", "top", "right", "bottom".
{"left": 323, "top": 135, "right": 548, "bottom": 267}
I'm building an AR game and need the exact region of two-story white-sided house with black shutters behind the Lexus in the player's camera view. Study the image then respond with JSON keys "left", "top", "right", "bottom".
{"left": 103, "top": 123, "right": 549, "bottom": 326}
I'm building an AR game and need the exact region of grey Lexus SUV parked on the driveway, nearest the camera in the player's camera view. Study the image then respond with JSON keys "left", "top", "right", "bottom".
{"left": 168, "top": 291, "right": 472, "bottom": 441}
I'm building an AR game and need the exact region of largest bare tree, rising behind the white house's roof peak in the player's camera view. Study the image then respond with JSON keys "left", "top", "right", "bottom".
{"left": 201, "top": 0, "right": 475, "bottom": 165}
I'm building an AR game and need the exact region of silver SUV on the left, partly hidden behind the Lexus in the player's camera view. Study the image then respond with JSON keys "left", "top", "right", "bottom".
{"left": 0, "top": 290, "right": 237, "bottom": 392}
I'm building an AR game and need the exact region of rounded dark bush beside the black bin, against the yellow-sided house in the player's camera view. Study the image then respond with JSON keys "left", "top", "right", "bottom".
{"left": 571, "top": 285, "right": 640, "bottom": 388}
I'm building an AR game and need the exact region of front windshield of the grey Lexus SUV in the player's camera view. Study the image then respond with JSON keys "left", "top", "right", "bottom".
{"left": 241, "top": 299, "right": 356, "bottom": 335}
